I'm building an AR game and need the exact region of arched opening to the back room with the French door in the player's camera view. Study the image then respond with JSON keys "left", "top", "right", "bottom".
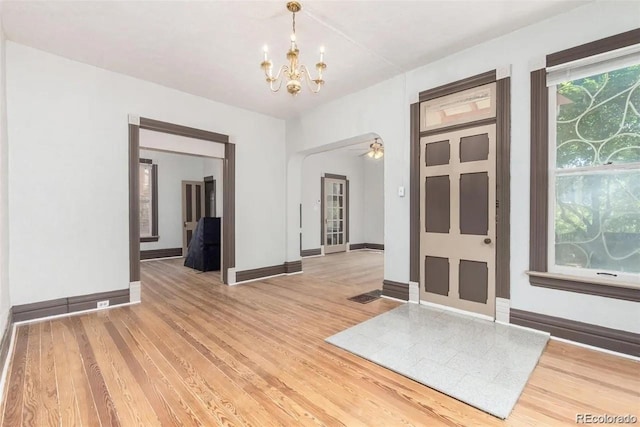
{"left": 300, "top": 134, "right": 384, "bottom": 264}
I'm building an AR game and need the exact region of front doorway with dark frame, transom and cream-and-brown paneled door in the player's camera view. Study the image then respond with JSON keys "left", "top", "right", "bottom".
{"left": 407, "top": 71, "right": 510, "bottom": 322}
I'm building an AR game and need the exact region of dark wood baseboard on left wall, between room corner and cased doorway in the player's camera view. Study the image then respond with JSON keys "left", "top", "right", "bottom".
{"left": 12, "top": 289, "right": 129, "bottom": 322}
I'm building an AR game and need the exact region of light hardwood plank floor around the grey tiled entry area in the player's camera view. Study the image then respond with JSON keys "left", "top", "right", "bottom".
{"left": 2, "top": 252, "right": 640, "bottom": 426}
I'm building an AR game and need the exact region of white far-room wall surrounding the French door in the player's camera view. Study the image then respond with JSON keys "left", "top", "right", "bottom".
{"left": 302, "top": 151, "right": 364, "bottom": 249}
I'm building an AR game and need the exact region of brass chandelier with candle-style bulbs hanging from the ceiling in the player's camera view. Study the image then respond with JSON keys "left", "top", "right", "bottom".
{"left": 260, "top": 1, "right": 327, "bottom": 95}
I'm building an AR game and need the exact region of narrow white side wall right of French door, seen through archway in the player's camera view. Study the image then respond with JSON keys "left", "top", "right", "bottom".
{"left": 362, "top": 157, "right": 384, "bottom": 245}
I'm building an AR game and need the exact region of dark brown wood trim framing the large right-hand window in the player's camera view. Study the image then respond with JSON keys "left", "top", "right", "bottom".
{"left": 529, "top": 29, "right": 640, "bottom": 301}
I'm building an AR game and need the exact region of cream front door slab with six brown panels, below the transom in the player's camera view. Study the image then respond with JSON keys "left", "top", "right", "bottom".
{"left": 420, "top": 124, "right": 496, "bottom": 317}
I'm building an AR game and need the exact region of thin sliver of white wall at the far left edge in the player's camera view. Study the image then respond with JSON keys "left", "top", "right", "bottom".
{"left": 0, "top": 19, "right": 11, "bottom": 334}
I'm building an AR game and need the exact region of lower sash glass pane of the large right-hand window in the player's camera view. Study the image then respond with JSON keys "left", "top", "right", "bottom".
{"left": 555, "top": 169, "right": 640, "bottom": 273}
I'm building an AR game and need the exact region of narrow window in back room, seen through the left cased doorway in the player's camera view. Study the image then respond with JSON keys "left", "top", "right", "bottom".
{"left": 139, "top": 159, "right": 159, "bottom": 242}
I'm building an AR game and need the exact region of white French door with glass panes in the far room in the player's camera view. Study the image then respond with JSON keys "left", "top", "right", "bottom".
{"left": 322, "top": 178, "right": 349, "bottom": 254}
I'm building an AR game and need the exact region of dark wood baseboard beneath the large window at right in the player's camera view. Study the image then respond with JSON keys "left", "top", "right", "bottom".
{"left": 509, "top": 308, "right": 640, "bottom": 357}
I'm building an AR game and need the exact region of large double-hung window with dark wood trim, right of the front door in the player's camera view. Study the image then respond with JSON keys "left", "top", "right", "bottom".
{"left": 529, "top": 30, "right": 640, "bottom": 301}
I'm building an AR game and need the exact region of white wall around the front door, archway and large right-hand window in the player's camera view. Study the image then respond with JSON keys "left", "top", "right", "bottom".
{"left": 287, "top": 2, "right": 640, "bottom": 333}
